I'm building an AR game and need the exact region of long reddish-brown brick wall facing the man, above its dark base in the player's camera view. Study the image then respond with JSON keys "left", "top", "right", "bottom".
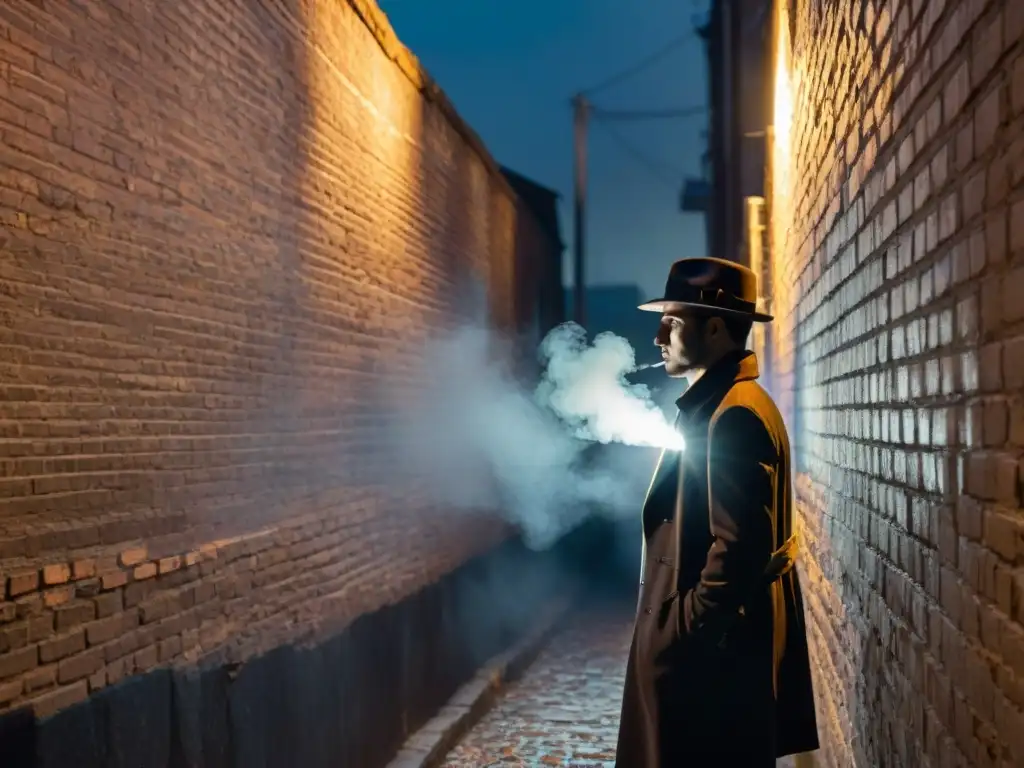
{"left": 0, "top": 0, "right": 536, "bottom": 713}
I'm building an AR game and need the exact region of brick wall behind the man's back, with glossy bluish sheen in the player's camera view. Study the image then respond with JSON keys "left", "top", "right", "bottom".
{"left": 773, "top": 0, "right": 1024, "bottom": 768}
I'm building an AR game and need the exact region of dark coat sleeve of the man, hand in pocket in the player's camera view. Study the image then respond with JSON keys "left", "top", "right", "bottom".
{"left": 680, "top": 406, "right": 778, "bottom": 635}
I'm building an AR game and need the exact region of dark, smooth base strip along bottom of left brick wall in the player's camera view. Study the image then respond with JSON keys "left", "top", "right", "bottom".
{"left": 0, "top": 542, "right": 593, "bottom": 768}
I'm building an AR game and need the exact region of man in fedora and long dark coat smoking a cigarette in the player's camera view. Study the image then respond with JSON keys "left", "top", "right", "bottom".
{"left": 615, "top": 258, "right": 818, "bottom": 768}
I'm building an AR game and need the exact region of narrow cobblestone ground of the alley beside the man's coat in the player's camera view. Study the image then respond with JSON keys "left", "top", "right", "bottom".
{"left": 444, "top": 605, "right": 792, "bottom": 768}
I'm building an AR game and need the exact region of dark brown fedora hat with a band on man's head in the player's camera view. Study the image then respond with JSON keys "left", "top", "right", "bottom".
{"left": 639, "top": 256, "right": 774, "bottom": 323}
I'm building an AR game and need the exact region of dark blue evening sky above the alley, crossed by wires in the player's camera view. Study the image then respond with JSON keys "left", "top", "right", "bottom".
{"left": 380, "top": 0, "right": 707, "bottom": 295}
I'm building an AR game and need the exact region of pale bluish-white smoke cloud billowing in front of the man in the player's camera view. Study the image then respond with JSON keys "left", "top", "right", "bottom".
{"left": 380, "top": 324, "right": 680, "bottom": 549}
